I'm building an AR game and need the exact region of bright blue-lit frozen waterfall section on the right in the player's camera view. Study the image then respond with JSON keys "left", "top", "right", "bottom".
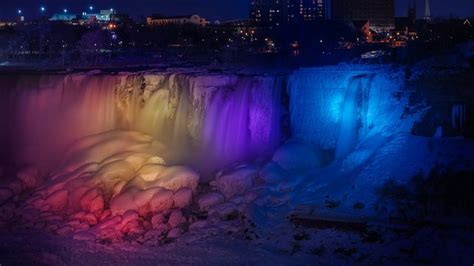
{"left": 287, "top": 65, "right": 417, "bottom": 158}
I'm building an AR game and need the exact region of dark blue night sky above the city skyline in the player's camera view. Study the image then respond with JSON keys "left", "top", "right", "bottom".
{"left": 0, "top": 0, "right": 474, "bottom": 20}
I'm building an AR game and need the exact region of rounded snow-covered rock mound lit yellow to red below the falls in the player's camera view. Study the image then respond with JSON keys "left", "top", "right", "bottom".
{"left": 10, "top": 131, "right": 200, "bottom": 241}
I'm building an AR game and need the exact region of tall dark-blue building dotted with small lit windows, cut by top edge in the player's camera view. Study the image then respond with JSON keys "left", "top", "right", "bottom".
{"left": 250, "top": 0, "right": 325, "bottom": 27}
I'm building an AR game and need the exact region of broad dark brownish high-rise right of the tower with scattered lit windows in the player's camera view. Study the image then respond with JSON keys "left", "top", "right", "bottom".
{"left": 331, "top": 0, "right": 395, "bottom": 32}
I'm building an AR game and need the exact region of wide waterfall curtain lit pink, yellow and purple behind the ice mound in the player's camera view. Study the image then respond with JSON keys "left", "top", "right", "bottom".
{"left": 0, "top": 73, "right": 281, "bottom": 170}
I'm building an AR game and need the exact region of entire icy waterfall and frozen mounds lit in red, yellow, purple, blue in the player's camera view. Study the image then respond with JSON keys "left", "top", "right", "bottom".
{"left": 0, "top": 66, "right": 466, "bottom": 249}
